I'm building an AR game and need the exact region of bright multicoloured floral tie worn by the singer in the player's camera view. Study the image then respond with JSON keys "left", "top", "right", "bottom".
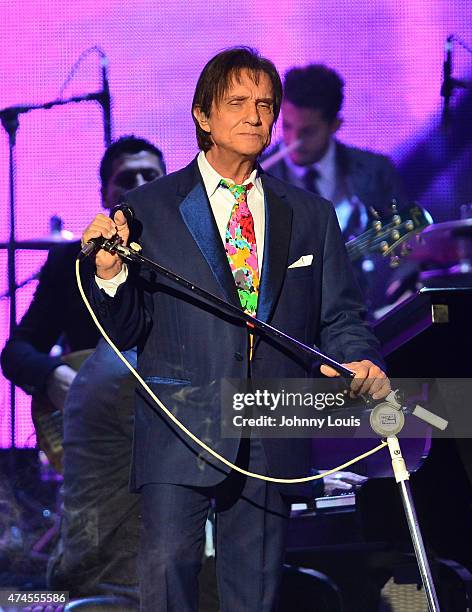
{"left": 220, "top": 179, "right": 259, "bottom": 316}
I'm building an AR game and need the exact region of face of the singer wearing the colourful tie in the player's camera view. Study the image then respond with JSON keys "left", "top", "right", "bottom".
{"left": 195, "top": 70, "right": 274, "bottom": 159}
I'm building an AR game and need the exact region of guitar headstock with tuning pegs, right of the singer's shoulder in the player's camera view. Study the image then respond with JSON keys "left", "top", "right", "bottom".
{"left": 346, "top": 200, "right": 432, "bottom": 267}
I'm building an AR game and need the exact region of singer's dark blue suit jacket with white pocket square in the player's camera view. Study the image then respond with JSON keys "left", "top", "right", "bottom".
{"left": 92, "top": 161, "right": 381, "bottom": 492}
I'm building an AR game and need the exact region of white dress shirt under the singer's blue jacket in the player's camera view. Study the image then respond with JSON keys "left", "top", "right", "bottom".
{"left": 95, "top": 151, "right": 265, "bottom": 297}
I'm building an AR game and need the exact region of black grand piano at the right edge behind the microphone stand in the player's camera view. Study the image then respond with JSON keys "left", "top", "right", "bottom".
{"left": 287, "top": 288, "right": 472, "bottom": 612}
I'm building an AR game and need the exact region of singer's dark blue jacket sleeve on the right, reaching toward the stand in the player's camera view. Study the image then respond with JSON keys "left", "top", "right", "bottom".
{"left": 320, "top": 207, "right": 384, "bottom": 368}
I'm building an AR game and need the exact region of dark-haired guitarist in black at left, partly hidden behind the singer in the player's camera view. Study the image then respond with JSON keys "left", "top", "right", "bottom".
{"left": 2, "top": 136, "right": 165, "bottom": 596}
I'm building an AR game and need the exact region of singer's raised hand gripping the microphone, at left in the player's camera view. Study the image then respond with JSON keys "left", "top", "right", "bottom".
{"left": 81, "top": 210, "right": 129, "bottom": 280}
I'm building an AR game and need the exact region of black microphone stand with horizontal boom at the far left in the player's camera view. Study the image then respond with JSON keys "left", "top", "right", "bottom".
{"left": 0, "top": 91, "right": 109, "bottom": 447}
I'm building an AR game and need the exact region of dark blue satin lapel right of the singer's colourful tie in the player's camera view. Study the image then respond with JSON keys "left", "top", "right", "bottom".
{"left": 257, "top": 174, "right": 293, "bottom": 323}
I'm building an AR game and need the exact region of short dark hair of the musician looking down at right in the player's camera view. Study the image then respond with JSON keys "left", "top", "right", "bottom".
{"left": 284, "top": 64, "right": 344, "bottom": 123}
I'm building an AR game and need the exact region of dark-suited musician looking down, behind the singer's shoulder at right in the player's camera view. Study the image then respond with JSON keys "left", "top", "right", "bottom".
{"left": 268, "top": 64, "right": 404, "bottom": 311}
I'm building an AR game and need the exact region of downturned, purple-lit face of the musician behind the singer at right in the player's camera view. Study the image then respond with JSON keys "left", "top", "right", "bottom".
{"left": 282, "top": 101, "right": 341, "bottom": 166}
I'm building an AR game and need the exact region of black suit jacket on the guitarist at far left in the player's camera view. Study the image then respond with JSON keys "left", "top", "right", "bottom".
{"left": 1, "top": 242, "right": 100, "bottom": 394}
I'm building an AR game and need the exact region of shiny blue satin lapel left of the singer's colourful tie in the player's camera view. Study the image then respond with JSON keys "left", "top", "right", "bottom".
{"left": 180, "top": 162, "right": 240, "bottom": 306}
